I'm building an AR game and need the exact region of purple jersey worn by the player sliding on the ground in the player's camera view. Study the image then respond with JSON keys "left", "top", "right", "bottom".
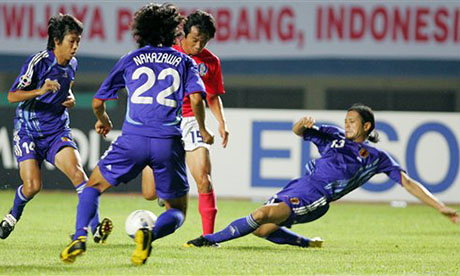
{"left": 304, "top": 125, "right": 403, "bottom": 201}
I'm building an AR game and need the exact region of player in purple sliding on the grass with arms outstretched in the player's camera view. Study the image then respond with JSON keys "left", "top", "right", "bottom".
{"left": 185, "top": 105, "right": 459, "bottom": 247}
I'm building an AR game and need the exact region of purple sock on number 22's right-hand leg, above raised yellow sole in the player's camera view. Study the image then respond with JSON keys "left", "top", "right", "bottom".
{"left": 152, "top": 208, "right": 184, "bottom": 240}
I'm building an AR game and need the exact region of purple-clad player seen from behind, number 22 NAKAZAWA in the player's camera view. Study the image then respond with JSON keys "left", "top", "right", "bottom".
{"left": 61, "top": 4, "right": 213, "bottom": 265}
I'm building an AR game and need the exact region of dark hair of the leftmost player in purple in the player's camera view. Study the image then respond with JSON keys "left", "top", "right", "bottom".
{"left": 47, "top": 13, "right": 83, "bottom": 50}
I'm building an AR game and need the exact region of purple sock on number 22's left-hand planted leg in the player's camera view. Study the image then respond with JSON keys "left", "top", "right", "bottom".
{"left": 74, "top": 187, "right": 101, "bottom": 240}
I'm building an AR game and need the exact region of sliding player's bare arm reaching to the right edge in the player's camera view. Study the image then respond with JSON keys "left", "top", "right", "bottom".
{"left": 401, "top": 172, "right": 459, "bottom": 223}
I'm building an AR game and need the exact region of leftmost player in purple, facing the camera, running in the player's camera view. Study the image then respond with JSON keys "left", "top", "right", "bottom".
{"left": 0, "top": 14, "right": 112, "bottom": 242}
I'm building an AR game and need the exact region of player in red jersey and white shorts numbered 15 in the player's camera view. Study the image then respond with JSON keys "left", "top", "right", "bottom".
{"left": 142, "top": 10, "right": 229, "bottom": 235}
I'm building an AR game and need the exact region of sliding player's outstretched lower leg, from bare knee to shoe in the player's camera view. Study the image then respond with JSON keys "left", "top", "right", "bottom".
{"left": 185, "top": 202, "right": 291, "bottom": 247}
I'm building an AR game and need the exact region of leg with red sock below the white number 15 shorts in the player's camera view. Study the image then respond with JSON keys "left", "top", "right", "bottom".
{"left": 186, "top": 147, "right": 217, "bottom": 235}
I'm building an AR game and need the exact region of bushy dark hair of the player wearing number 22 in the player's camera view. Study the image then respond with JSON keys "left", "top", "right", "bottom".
{"left": 131, "top": 3, "right": 184, "bottom": 47}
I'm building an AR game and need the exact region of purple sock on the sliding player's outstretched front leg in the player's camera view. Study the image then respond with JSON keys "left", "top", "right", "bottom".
{"left": 204, "top": 215, "right": 260, "bottom": 242}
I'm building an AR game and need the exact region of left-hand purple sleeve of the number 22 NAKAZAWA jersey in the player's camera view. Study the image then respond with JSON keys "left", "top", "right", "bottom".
{"left": 94, "top": 58, "right": 125, "bottom": 100}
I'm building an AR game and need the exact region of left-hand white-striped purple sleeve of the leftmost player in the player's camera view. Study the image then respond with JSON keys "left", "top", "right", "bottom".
{"left": 9, "top": 53, "right": 46, "bottom": 92}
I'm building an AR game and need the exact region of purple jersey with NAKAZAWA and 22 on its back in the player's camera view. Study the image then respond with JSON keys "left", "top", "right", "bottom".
{"left": 94, "top": 45, "right": 205, "bottom": 138}
